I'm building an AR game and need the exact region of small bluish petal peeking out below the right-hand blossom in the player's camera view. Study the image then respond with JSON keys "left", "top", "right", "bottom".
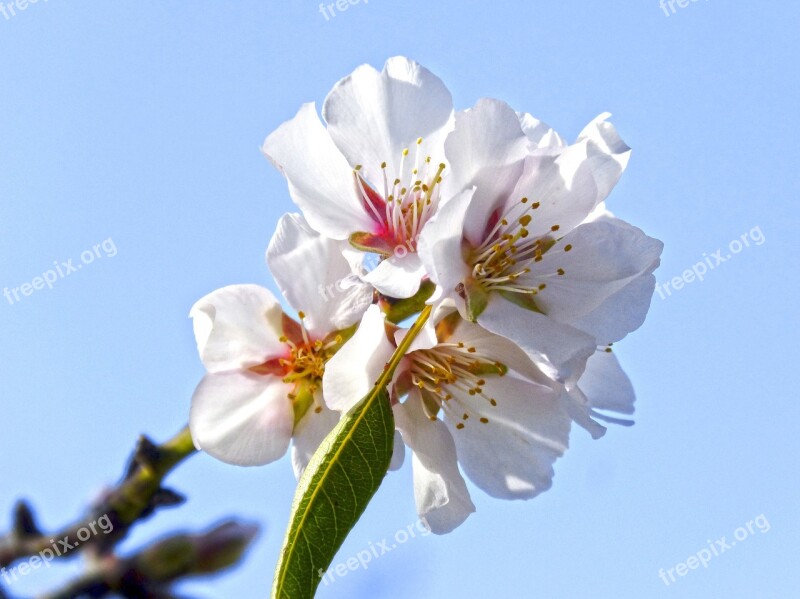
{"left": 578, "top": 349, "right": 636, "bottom": 414}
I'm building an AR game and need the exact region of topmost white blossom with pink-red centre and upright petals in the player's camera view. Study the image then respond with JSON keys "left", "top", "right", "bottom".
{"left": 262, "top": 57, "right": 453, "bottom": 298}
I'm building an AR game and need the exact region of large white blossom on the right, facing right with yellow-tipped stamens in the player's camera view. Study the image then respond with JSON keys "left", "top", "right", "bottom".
{"left": 419, "top": 100, "right": 662, "bottom": 382}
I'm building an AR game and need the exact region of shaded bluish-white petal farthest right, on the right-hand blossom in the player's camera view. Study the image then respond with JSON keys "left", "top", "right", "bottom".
{"left": 519, "top": 219, "right": 663, "bottom": 342}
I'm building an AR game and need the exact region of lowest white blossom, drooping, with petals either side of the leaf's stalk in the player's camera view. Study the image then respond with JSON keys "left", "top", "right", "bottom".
{"left": 323, "top": 307, "right": 571, "bottom": 534}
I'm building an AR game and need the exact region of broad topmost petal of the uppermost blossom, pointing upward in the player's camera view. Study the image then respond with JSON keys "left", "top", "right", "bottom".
{"left": 322, "top": 57, "right": 453, "bottom": 188}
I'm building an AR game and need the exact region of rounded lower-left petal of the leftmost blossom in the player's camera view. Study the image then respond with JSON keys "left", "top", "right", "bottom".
{"left": 189, "top": 372, "right": 294, "bottom": 466}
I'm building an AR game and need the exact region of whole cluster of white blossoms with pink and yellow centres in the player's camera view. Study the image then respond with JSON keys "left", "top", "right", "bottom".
{"left": 190, "top": 57, "right": 662, "bottom": 533}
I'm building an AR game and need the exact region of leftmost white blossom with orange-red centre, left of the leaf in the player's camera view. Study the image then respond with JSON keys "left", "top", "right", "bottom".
{"left": 189, "top": 215, "right": 372, "bottom": 477}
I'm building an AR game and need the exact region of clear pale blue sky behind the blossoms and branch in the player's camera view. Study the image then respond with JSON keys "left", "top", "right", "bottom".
{"left": 0, "top": 0, "right": 800, "bottom": 599}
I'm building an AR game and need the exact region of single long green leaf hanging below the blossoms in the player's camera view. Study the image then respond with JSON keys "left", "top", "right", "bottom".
{"left": 272, "top": 388, "right": 394, "bottom": 599}
